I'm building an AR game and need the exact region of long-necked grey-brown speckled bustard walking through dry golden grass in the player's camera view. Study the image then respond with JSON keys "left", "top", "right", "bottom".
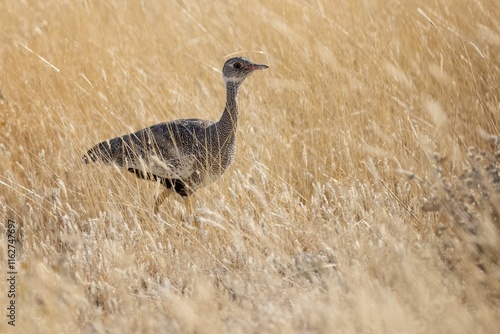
{"left": 82, "top": 57, "right": 269, "bottom": 214}
